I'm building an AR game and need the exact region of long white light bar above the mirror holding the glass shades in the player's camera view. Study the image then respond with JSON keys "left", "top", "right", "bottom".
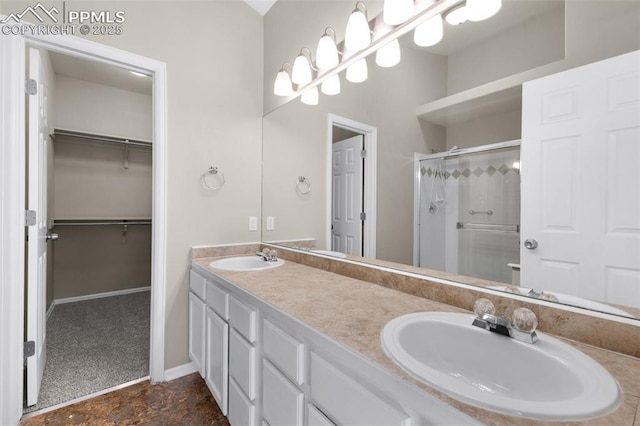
{"left": 297, "top": 0, "right": 464, "bottom": 95}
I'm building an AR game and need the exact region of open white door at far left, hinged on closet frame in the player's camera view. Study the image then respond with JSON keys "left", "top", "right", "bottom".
{"left": 26, "top": 49, "right": 49, "bottom": 406}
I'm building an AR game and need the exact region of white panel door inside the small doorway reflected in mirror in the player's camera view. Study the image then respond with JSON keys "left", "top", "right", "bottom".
{"left": 331, "top": 135, "right": 364, "bottom": 256}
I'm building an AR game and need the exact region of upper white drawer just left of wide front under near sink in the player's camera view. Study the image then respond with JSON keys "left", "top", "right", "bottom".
{"left": 262, "top": 319, "right": 304, "bottom": 385}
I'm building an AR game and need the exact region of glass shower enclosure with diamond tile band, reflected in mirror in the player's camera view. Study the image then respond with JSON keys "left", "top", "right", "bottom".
{"left": 414, "top": 141, "right": 520, "bottom": 283}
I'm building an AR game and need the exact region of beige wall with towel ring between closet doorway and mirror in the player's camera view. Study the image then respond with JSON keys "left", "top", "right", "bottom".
{"left": 0, "top": 0, "right": 264, "bottom": 368}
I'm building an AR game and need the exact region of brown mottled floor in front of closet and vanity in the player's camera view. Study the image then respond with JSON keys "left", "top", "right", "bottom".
{"left": 20, "top": 373, "right": 229, "bottom": 426}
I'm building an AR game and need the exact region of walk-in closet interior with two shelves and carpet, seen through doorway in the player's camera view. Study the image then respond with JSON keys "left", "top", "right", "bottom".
{"left": 25, "top": 51, "right": 153, "bottom": 412}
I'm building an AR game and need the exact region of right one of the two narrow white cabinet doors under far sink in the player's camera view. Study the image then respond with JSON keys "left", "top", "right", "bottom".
{"left": 205, "top": 309, "right": 229, "bottom": 415}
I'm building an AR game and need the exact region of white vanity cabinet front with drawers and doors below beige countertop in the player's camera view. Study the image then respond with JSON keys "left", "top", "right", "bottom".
{"left": 192, "top": 263, "right": 479, "bottom": 426}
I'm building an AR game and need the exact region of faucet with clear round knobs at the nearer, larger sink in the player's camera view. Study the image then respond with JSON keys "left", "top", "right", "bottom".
{"left": 472, "top": 299, "right": 538, "bottom": 343}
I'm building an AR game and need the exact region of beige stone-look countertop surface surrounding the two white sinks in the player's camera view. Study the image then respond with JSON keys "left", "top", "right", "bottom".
{"left": 194, "top": 258, "right": 640, "bottom": 426}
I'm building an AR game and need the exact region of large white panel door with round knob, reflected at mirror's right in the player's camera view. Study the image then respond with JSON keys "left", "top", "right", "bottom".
{"left": 520, "top": 52, "right": 640, "bottom": 307}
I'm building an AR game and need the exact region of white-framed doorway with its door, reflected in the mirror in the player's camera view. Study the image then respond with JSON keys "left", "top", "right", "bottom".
{"left": 326, "top": 114, "right": 377, "bottom": 258}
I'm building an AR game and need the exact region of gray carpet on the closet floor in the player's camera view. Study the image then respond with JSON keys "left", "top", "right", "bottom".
{"left": 25, "top": 291, "right": 151, "bottom": 413}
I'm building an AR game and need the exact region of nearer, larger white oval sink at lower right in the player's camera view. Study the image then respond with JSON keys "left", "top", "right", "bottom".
{"left": 382, "top": 312, "right": 621, "bottom": 421}
